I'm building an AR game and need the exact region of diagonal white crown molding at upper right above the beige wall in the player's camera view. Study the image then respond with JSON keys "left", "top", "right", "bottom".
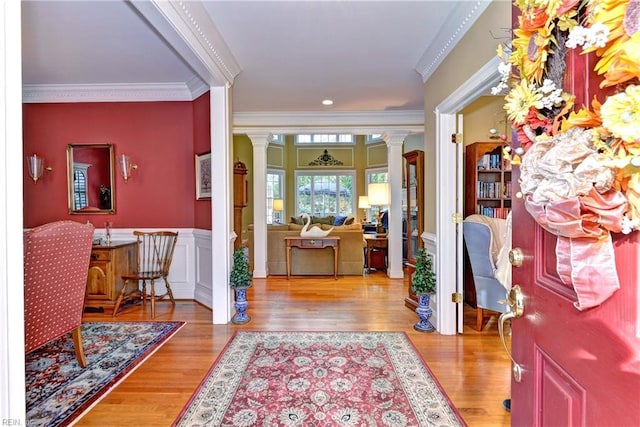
{"left": 415, "top": 0, "right": 491, "bottom": 83}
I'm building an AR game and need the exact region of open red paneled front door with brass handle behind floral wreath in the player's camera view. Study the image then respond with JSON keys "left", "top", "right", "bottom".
{"left": 504, "top": 29, "right": 640, "bottom": 426}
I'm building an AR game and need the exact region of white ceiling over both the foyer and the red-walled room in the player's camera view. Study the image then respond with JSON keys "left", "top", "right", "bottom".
{"left": 22, "top": 0, "right": 488, "bottom": 117}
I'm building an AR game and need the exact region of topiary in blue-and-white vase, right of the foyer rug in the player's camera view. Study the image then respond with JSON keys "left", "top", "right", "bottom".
{"left": 411, "top": 248, "right": 436, "bottom": 332}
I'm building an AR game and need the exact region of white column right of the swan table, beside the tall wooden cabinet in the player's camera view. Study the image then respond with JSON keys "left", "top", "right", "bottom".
{"left": 382, "top": 131, "right": 409, "bottom": 279}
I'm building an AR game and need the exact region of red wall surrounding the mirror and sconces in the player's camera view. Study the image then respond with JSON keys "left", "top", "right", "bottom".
{"left": 23, "top": 98, "right": 211, "bottom": 229}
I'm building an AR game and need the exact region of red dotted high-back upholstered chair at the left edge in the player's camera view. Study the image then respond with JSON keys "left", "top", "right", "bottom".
{"left": 24, "top": 221, "right": 93, "bottom": 367}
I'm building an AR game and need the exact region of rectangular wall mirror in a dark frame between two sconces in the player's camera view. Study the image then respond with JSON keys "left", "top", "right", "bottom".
{"left": 67, "top": 144, "right": 116, "bottom": 214}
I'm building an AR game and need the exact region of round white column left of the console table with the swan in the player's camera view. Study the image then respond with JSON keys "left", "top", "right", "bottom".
{"left": 247, "top": 133, "right": 272, "bottom": 278}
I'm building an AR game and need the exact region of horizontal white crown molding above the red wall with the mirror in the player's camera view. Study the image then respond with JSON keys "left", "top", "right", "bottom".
{"left": 22, "top": 83, "right": 198, "bottom": 104}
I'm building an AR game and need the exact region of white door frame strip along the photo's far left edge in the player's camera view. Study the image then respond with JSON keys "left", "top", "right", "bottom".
{"left": 0, "top": 1, "right": 26, "bottom": 425}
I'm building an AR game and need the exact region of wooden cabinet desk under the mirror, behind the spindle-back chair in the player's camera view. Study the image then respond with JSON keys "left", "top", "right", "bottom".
{"left": 84, "top": 241, "right": 138, "bottom": 313}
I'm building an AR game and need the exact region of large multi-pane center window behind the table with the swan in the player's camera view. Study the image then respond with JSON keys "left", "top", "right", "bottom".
{"left": 296, "top": 171, "right": 355, "bottom": 216}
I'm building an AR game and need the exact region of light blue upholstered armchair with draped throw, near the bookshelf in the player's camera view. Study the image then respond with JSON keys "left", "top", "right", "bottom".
{"left": 463, "top": 215, "right": 511, "bottom": 331}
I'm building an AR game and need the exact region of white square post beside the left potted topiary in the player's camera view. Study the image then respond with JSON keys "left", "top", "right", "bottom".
{"left": 210, "top": 86, "right": 234, "bottom": 324}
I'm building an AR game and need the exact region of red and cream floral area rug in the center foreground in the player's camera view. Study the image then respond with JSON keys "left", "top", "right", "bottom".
{"left": 173, "top": 332, "right": 466, "bottom": 427}
